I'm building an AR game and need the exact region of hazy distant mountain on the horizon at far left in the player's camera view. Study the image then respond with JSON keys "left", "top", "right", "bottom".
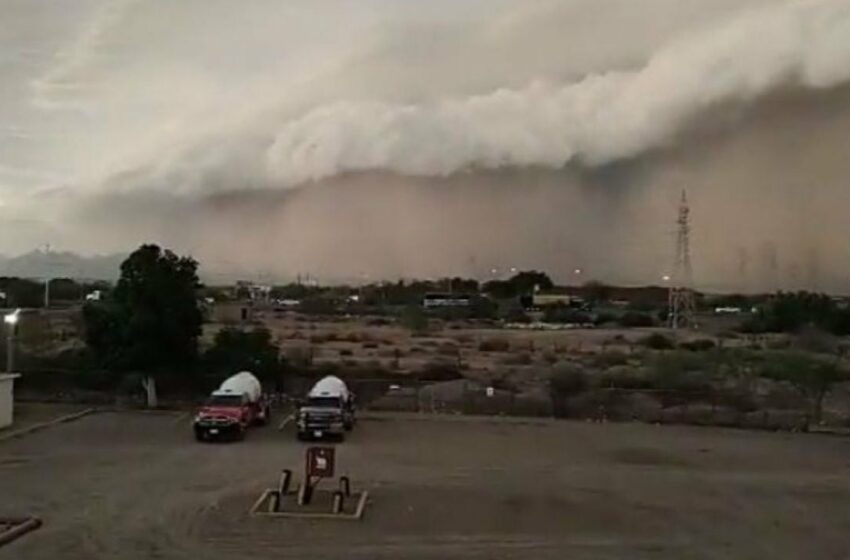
{"left": 0, "top": 251, "right": 126, "bottom": 280}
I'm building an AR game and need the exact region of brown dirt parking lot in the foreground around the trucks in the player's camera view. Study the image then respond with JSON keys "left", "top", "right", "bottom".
{"left": 0, "top": 406, "right": 850, "bottom": 560}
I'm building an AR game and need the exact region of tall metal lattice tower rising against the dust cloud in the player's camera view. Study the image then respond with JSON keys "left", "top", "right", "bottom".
{"left": 667, "top": 191, "right": 696, "bottom": 329}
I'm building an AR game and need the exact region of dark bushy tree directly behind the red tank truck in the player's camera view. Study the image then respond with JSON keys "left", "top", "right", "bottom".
{"left": 204, "top": 327, "right": 283, "bottom": 387}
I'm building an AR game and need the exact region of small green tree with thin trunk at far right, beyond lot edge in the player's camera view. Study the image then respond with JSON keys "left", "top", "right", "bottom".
{"left": 761, "top": 350, "right": 847, "bottom": 427}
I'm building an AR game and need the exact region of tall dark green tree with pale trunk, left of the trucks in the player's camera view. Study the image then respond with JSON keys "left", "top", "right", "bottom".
{"left": 83, "top": 245, "right": 202, "bottom": 407}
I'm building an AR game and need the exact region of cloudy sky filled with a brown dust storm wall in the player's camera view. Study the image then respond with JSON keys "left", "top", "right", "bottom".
{"left": 0, "top": 0, "right": 850, "bottom": 291}
